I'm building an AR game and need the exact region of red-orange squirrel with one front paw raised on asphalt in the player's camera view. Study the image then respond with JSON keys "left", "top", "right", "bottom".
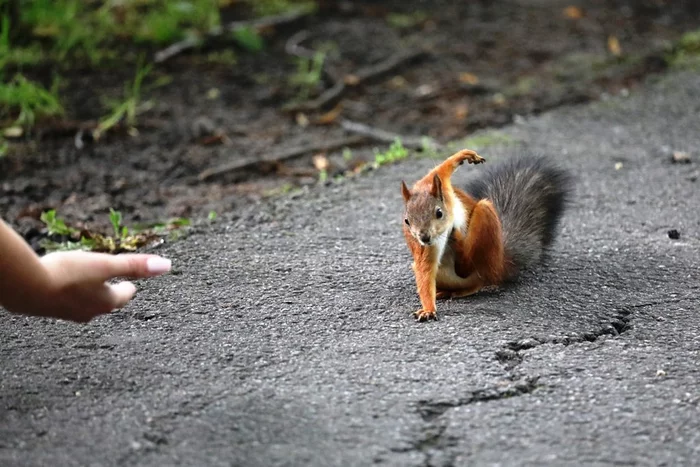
{"left": 401, "top": 149, "right": 573, "bottom": 321}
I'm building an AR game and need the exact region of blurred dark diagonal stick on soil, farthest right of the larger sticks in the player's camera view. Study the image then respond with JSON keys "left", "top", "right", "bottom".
{"left": 284, "top": 50, "right": 427, "bottom": 112}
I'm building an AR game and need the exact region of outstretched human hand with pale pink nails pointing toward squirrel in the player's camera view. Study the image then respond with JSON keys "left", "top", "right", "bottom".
{"left": 31, "top": 251, "right": 171, "bottom": 323}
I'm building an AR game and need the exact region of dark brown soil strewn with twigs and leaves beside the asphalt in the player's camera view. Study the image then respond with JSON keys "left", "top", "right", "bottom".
{"left": 0, "top": 0, "right": 700, "bottom": 252}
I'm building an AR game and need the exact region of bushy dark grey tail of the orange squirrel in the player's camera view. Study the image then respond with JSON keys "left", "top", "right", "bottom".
{"left": 465, "top": 155, "right": 573, "bottom": 278}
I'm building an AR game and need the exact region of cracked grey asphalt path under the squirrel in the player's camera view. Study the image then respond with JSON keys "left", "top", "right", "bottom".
{"left": 0, "top": 73, "right": 700, "bottom": 467}
